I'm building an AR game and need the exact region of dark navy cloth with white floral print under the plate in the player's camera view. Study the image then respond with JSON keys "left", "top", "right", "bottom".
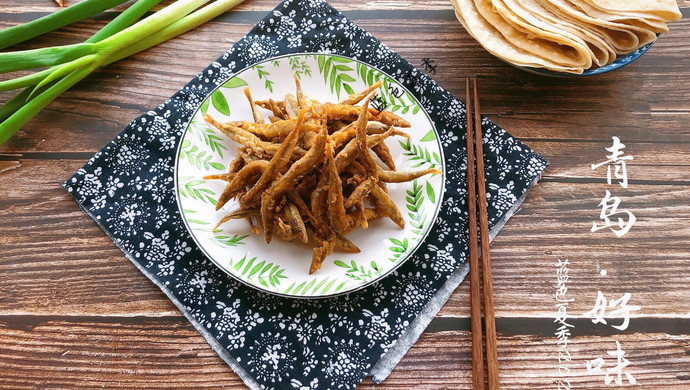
{"left": 64, "top": 0, "right": 548, "bottom": 389}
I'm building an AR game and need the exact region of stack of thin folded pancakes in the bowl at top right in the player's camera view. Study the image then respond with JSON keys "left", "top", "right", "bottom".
{"left": 451, "top": 0, "right": 681, "bottom": 74}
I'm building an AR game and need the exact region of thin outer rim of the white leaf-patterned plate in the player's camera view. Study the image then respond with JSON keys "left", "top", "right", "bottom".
{"left": 173, "top": 52, "right": 446, "bottom": 300}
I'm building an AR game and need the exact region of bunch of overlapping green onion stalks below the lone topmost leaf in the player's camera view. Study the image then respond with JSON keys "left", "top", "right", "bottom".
{"left": 0, "top": 0, "right": 243, "bottom": 145}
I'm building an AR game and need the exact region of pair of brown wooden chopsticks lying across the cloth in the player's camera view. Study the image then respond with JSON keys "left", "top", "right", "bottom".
{"left": 466, "top": 78, "right": 499, "bottom": 390}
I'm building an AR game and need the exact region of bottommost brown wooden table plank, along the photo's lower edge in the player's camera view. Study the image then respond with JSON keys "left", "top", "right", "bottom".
{"left": 0, "top": 316, "right": 690, "bottom": 389}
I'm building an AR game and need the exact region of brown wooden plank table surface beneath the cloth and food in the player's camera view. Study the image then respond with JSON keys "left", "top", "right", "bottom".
{"left": 0, "top": 0, "right": 690, "bottom": 389}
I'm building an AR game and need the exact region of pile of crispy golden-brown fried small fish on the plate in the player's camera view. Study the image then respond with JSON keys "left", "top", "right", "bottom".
{"left": 204, "top": 76, "right": 441, "bottom": 273}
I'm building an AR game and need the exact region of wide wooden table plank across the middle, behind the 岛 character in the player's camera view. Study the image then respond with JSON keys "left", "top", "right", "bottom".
{"left": 0, "top": 160, "right": 690, "bottom": 317}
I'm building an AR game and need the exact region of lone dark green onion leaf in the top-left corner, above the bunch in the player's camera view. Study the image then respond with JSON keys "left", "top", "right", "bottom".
{"left": 0, "top": 0, "right": 128, "bottom": 50}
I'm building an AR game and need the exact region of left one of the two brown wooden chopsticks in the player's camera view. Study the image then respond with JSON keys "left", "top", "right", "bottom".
{"left": 465, "top": 78, "right": 484, "bottom": 390}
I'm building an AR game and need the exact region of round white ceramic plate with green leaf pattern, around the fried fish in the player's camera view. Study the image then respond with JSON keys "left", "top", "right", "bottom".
{"left": 175, "top": 54, "right": 445, "bottom": 298}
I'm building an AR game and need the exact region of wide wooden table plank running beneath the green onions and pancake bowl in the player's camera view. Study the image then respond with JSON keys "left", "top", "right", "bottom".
{"left": 0, "top": 16, "right": 690, "bottom": 153}
